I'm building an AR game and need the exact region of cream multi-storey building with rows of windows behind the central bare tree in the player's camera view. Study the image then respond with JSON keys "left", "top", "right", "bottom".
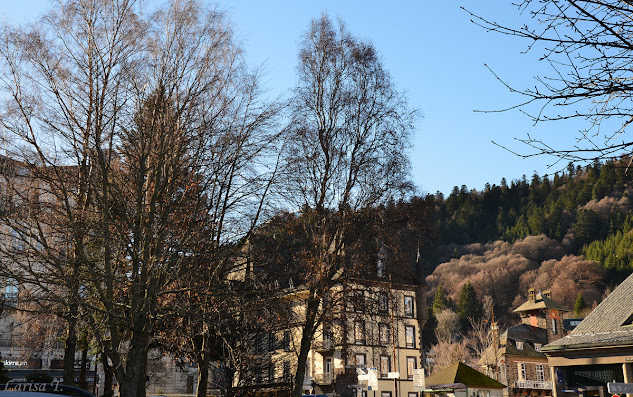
{"left": 241, "top": 280, "right": 422, "bottom": 397}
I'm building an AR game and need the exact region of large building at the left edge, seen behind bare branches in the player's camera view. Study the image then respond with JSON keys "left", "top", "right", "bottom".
{"left": 0, "top": 156, "right": 96, "bottom": 389}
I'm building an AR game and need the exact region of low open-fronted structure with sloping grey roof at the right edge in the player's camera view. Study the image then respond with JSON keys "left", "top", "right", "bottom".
{"left": 542, "top": 274, "right": 633, "bottom": 397}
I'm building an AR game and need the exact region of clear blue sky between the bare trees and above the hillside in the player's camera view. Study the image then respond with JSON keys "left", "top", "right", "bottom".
{"left": 0, "top": 0, "right": 581, "bottom": 194}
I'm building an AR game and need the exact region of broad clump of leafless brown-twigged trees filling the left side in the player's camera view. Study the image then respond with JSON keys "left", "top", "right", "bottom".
{"left": 0, "top": 0, "right": 274, "bottom": 396}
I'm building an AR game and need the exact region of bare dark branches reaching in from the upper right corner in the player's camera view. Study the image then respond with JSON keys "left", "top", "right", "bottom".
{"left": 471, "top": 0, "right": 633, "bottom": 164}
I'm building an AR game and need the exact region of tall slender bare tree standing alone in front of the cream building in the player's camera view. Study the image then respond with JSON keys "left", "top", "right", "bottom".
{"left": 281, "top": 15, "right": 415, "bottom": 397}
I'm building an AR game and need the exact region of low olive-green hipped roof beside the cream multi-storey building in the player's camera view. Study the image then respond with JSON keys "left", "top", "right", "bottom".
{"left": 424, "top": 362, "right": 506, "bottom": 397}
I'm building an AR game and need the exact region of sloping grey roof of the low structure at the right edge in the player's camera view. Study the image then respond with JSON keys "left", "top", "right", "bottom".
{"left": 543, "top": 274, "right": 633, "bottom": 351}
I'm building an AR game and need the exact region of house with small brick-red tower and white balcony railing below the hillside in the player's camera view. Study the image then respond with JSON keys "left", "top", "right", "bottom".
{"left": 480, "top": 288, "right": 569, "bottom": 397}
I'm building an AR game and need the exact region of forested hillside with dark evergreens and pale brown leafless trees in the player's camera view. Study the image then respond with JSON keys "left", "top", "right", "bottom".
{"left": 425, "top": 158, "right": 633, "bottom": 328}
